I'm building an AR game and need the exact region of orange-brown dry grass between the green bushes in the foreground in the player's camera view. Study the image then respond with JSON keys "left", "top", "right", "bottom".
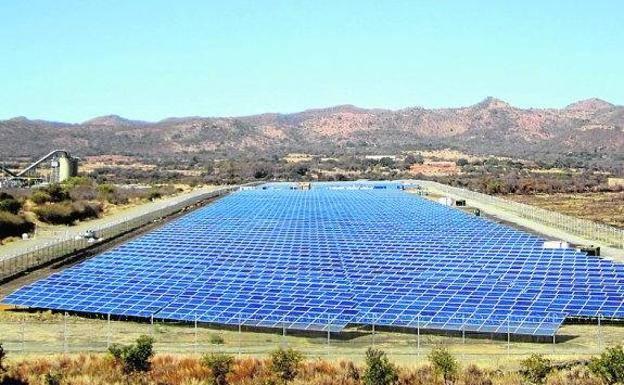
{"left": 0, "top": 354, "right": 604, "bottom": 385}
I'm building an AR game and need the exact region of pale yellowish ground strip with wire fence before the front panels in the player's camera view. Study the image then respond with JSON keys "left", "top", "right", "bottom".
{"left": 0, "top": 313, "right": 608, "bottom": 363}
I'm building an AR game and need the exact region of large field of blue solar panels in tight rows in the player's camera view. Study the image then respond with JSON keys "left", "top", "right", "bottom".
{"left": 3, "top": 182, "right": 624, "bottom": 336}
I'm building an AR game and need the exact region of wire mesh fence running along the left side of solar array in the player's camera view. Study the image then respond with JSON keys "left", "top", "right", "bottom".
{"left": 0, "top": 186, "right": 239, "bottom": 281}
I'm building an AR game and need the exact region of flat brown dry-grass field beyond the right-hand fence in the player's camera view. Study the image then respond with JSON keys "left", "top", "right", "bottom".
{"left": 504, "top": 192, "right": 624, "bottom": 228}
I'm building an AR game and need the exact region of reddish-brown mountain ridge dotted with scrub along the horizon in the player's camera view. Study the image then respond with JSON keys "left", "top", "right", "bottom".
{"left": 0, "top": 97, "right": 624, "bottom": 158}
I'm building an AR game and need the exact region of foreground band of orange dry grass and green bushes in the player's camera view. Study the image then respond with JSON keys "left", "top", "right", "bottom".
{"left": 0, "top": 336, "right": 624, "bottom": 385}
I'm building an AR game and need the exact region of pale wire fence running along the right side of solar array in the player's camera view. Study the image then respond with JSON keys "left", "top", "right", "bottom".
{"left": 417, "top": 181, "right": 624, "bottom": 248}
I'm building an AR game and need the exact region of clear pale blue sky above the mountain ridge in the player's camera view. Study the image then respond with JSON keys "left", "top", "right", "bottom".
{"left": 0, "top": 0, "right": 624, "bottom": 122}
